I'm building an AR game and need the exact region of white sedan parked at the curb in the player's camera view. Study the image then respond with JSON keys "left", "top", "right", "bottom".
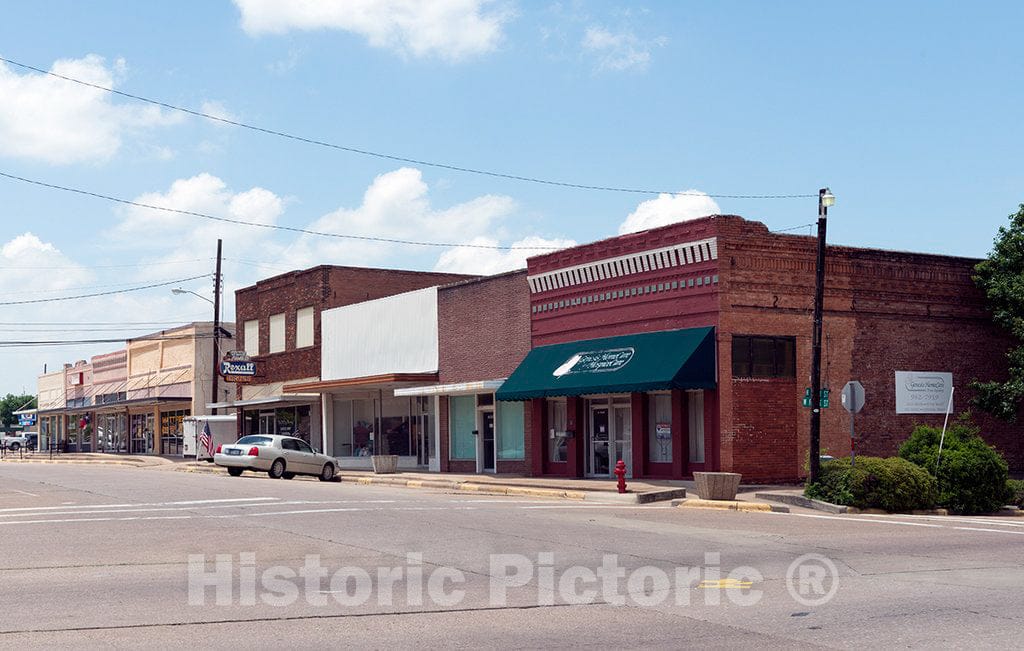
{"left": 213, "top": 434, "right": 337, "bottom": 481}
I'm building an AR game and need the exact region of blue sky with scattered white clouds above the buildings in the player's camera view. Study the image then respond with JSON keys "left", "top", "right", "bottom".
{"left": 0, "top": 0, "right": 1024, "bottom": 392}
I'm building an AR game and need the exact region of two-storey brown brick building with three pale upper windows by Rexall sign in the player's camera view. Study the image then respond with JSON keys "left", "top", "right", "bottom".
{"left": 231, "top": 265, "right": 472, "bottom": 445}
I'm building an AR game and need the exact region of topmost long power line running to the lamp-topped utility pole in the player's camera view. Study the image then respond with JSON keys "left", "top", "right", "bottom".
{"left": 0, "top": 56, "right": 817, "bottom": 199}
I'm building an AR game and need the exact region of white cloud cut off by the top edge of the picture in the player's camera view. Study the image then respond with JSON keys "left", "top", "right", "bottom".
{"left": 234, "top": 0, "right": 511, "bottom": 61}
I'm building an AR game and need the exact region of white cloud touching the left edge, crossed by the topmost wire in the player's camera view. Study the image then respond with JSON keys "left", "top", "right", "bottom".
{"left": 0, "top": 54, "right": 182, "bottom": 165}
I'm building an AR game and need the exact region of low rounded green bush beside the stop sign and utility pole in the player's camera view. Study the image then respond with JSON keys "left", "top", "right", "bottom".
{"left": 804, "top": 457, "right": 936, "bottom": 512}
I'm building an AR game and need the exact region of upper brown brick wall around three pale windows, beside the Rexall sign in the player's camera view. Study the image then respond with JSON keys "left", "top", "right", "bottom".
{"left": 234, "top": 265, "right": 474, "bottom": 391}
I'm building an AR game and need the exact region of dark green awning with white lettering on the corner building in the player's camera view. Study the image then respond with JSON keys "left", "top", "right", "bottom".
{"left": 497, "top": 328, "right": 716, "bottom": 400}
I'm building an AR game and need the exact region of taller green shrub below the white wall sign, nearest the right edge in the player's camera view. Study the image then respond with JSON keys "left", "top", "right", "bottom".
{"left": 899, "top": 415, "right": 1010, "bottom": 514}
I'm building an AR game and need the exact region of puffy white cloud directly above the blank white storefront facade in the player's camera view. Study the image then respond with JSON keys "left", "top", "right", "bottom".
{"left": 289, "top": 168, "right": 516, "bottom": 266}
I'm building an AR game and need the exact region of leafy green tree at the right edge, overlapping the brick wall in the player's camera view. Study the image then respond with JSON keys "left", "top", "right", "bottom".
{"left": 971, "top": 204, "right": 1024, "bottom": 423}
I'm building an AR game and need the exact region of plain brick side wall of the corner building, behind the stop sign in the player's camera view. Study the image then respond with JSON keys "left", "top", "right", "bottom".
{"left": 717, "top": 217, "right": 1024, "bottom": 479}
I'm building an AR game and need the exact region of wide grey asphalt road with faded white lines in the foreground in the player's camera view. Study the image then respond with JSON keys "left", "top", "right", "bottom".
{"left": 0, "top": 465, "right": 1024, "bottom": 649}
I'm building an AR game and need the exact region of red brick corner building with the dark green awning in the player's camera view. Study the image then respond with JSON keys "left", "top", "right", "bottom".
{"left": 498, "top": 216, "right": 1024, "bottom": 480}
